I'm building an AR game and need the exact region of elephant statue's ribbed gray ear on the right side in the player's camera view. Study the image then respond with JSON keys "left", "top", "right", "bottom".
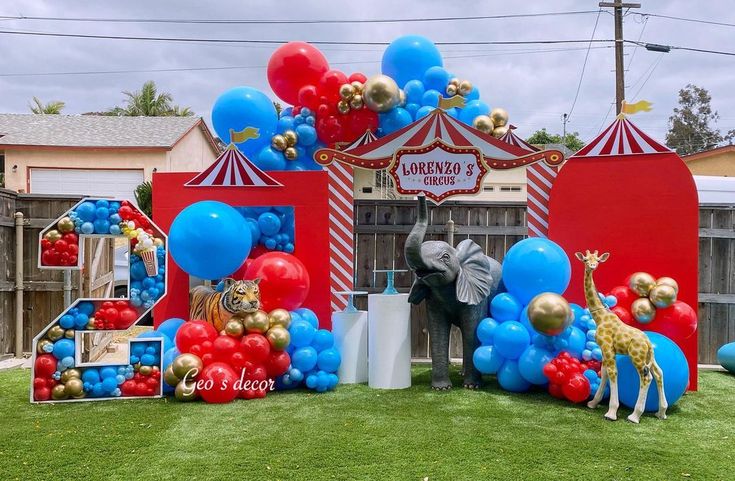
{"left": 457, "top": 239, "right": 493, "bottom": 305}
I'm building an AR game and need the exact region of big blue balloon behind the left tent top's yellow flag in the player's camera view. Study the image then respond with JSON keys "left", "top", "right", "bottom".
{"left": 212, "top": 87, "right": 278, "bottom": 158}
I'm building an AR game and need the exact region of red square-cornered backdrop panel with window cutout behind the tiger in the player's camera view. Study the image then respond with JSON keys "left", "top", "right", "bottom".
{"left": 153, "top": 171, "right": 331, "bottom": 329}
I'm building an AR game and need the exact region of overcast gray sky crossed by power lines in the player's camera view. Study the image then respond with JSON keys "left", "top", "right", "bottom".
{"left": 0, "top": 0, "right": 735, "bottom": 141}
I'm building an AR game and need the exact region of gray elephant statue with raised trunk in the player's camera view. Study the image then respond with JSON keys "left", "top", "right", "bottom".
{"left": 405, "top": 195, "right": 502, "bottom": 389}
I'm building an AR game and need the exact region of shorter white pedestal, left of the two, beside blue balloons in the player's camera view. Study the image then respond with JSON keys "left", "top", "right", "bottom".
{"left": 332, "top": 311, "right": 368, "bottom": 384}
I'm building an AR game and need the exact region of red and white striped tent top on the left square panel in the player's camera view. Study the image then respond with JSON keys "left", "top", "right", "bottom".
{"left": 185, "top": 144, "right": 282, "bottom": 187}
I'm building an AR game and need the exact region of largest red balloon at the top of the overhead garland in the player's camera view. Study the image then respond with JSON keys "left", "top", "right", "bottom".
{"left": 268, "top": 42, "right": 329, "bottom": 105}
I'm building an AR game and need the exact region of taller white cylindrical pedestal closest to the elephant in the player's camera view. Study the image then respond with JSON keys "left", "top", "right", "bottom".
{"left": 368, "top": 294, "right": 411, "bottom": 389}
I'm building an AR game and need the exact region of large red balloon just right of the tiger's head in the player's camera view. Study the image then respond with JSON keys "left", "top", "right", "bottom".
{"left": 243, "top": 252, "right": 310, "bottom": 310}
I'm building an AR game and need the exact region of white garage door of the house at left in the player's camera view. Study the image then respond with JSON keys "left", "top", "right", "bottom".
{"left": 30, "top": 168, "right": 144, "bottom": 201}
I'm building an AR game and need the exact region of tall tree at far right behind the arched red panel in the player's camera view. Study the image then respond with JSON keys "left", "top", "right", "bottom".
{"left": 666, "top": 84, "right": 723, "bottom": 155}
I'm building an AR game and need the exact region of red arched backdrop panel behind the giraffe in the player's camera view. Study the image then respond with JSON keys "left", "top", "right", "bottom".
{"left": 549, "top": 153, "right": 699, "bottom": 390}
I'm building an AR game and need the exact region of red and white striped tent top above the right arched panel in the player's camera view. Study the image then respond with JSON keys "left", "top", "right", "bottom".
{"left": 573, "top": 115, "right": 671, "bottom": 157}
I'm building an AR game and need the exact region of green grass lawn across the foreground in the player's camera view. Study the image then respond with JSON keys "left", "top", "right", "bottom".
{"left": 0, "top": 366, "right": 735, "bottom": 481}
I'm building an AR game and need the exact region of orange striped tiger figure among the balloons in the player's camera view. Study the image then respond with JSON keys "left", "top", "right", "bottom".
{"left": 189, "top": 278, "right": 260, "bottom": 332}
